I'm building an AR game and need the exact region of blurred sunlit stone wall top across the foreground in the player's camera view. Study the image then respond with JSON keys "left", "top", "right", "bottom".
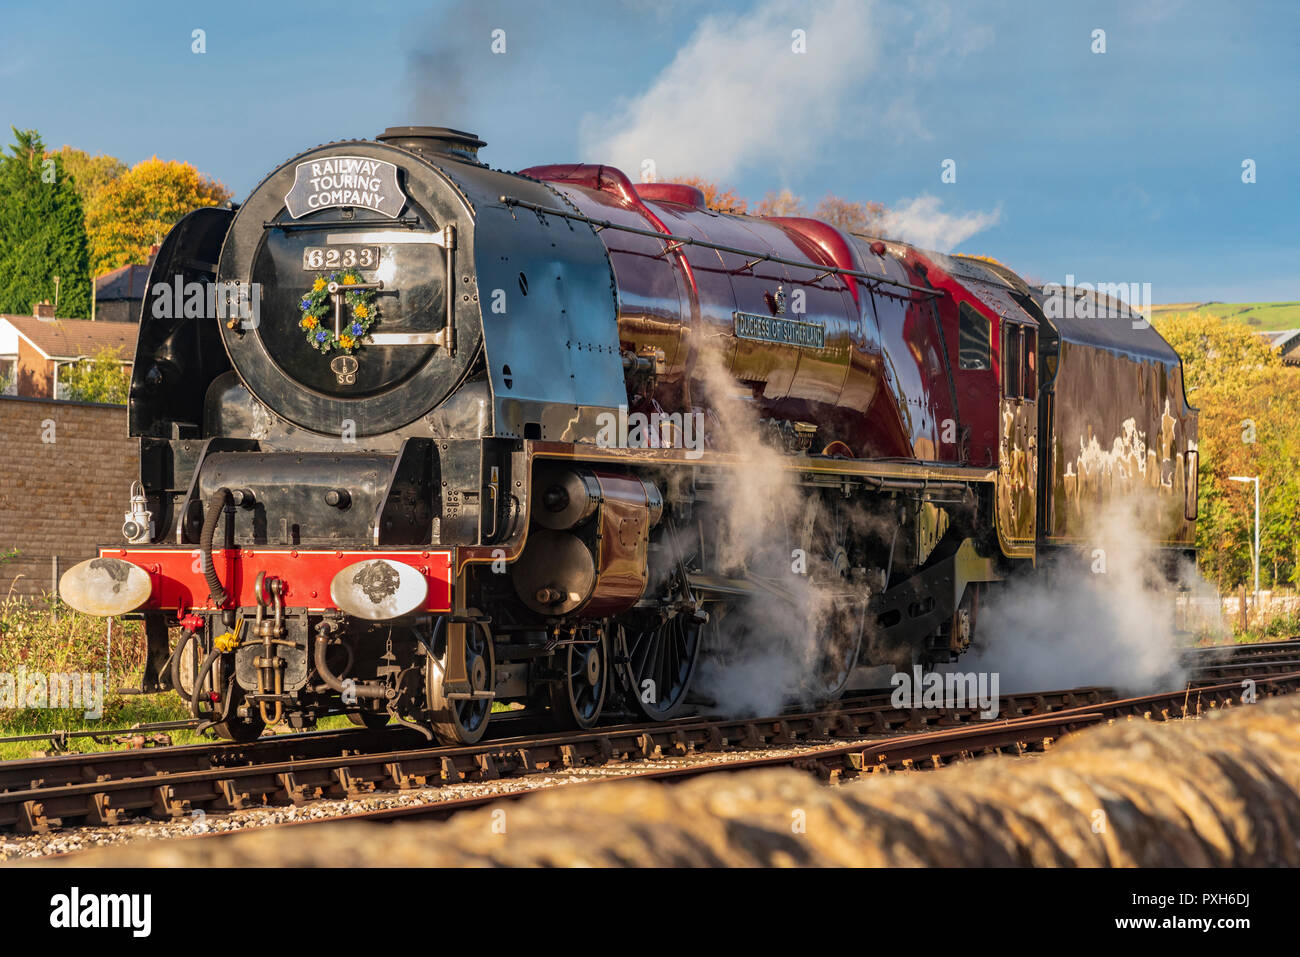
{"left": 65, "top": 696, "right": 1300, "bottom": 867}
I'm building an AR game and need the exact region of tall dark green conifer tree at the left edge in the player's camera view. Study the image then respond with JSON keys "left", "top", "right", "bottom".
{"left": 0, "top": 127, "right": 90, "bottom": 316}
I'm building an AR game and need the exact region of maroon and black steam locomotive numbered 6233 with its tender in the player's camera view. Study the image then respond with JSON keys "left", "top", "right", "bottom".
{"left": 60, "top": 127, "right": 1196, "bottom": 742}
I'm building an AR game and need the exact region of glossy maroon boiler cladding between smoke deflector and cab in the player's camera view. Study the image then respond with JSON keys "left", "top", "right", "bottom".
{"left": 524, "top": 164, "right": 977, "bottom": 462}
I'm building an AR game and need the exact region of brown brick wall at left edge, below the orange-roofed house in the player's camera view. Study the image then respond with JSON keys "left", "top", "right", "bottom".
{"left": 0, "top": 397, "right": 139, "bottom": 598}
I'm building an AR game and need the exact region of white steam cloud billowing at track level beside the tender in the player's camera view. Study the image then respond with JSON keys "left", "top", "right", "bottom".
{"left": 953, "top": 490, "right": 1213, "bottom": 694}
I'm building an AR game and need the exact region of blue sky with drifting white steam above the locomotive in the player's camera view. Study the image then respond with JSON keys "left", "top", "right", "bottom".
{"left": 0, "top": 0, "right": 1300, "bottom": 302}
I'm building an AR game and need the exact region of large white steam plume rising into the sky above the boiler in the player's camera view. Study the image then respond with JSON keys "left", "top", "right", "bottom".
{"left": 581, "top": 0, "right": 880, "bottom": 178}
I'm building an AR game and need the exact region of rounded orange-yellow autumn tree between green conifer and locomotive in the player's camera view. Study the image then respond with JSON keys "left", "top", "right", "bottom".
{"left": 86, "top": 156, "right": 230, "bottom": 276}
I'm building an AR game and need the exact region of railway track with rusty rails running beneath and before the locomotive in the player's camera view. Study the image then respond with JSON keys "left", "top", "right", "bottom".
{"left": 0, "top": 642, "right": 1300, "bottom": 833}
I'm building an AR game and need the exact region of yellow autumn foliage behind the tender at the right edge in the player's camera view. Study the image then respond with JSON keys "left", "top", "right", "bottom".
{"left": 1156, "top": 312, "right": 1300, "bottom": 588}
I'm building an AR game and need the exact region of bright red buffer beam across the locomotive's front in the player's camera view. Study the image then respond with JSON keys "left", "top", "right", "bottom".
{"left": 99, "top": 547, "right": 452, "bottom": 611}
